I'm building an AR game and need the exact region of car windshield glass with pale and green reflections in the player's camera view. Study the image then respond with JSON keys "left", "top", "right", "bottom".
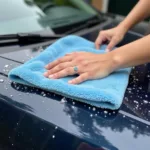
{"left": 0, "top": 0, "right": 98, "bottom": 34}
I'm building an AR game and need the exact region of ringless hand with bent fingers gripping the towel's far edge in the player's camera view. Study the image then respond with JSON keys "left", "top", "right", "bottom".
{"left": 95, "top": 26, "right": 126, "bottom": 52}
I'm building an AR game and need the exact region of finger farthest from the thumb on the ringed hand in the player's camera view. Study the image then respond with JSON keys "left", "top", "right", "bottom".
{"left": 45, "top": 55, "right": 72, "bottom": 70}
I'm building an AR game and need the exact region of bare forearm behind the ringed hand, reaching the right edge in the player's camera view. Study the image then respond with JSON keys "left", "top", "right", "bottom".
{"left": 110, "top": 35, "right": 150, "bottom": 69}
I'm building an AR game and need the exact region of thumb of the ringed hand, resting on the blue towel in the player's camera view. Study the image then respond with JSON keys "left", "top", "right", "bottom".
{"left": 69, "top": 73, "right": 89, "bottom": 84}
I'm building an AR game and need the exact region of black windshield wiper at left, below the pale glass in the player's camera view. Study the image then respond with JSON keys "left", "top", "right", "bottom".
{"left": 0, "top": 33, "right": 64, "bottom": 46}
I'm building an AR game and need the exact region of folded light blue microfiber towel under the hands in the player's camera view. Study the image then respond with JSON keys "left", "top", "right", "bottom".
{"left": 9, "top": 35, "right": 131, "bottom": 110}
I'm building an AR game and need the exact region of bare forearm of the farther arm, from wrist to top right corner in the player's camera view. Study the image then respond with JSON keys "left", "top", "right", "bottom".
{"left": 118, "top": 0, "right": 150, "bottom": 32}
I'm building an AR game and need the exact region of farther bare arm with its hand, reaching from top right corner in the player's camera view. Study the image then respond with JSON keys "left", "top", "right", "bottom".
{"left": 95, "top": 0, "right": 150, "bottom": 51}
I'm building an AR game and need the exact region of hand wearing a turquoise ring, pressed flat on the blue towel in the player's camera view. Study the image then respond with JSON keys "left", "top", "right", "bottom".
{"left": 44, "top": 52, "right": 116, "bottom": 84}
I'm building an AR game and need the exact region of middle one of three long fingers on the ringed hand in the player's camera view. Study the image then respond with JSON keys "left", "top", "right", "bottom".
{"left": 44, "top": 62, "right": 73, "bottom": 77}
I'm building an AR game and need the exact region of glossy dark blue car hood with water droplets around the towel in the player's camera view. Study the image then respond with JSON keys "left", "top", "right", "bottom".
{"left": 0, "top": 20, "right": 150, "bottom": 150}
